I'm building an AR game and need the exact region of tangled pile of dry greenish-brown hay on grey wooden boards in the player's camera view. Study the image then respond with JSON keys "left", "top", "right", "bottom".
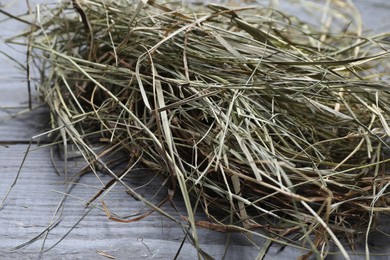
{"left": 7, "top": 0, "right": 390, "bottom": 256}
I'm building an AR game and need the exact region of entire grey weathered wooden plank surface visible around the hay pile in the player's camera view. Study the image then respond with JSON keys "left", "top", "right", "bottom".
{"left": 0, "top": 0, "right": 390, "bottom": 259}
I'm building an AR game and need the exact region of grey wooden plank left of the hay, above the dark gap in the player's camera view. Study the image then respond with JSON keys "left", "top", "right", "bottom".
{"left": 0, "top": 1, "right": 45, "bottom": 143}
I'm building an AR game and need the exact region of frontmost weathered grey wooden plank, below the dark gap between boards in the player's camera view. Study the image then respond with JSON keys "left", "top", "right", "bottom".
{"left": 0, "top": 145, "right": 268, "bottom": 259}
